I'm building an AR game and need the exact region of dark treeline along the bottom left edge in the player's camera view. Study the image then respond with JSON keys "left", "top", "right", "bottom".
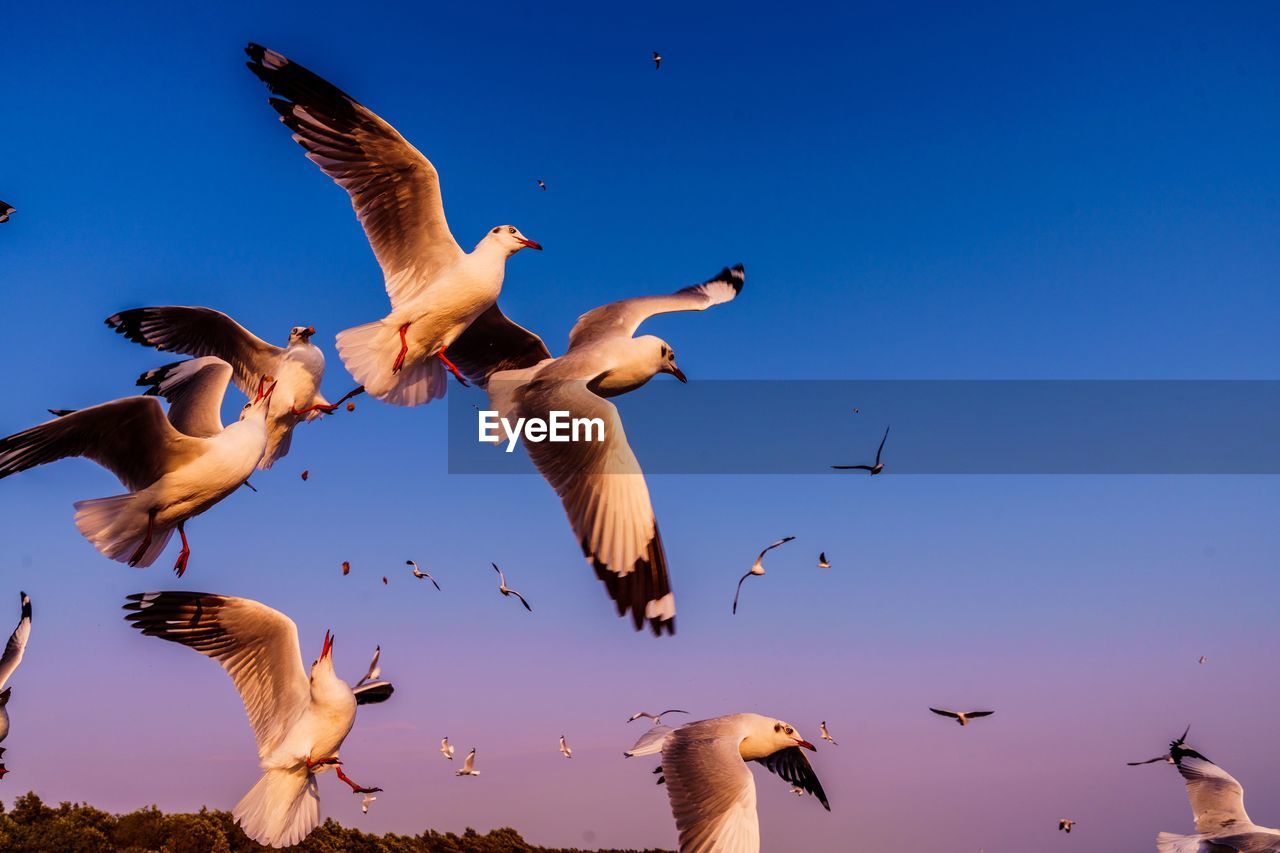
{"left": 0, "top": 793, "right": 655, "bottom": 853}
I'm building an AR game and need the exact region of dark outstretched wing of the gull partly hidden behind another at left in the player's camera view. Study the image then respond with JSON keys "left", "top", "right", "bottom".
{"left": 106, "top": 305, "right": 284, "bottom": 400}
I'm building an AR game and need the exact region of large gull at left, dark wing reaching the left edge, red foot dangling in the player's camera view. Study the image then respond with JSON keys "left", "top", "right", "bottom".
{"left": 0, "top": 357, "right": 275, "bottom": 578}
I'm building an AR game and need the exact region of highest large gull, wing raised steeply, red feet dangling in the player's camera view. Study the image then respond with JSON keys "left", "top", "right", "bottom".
{"left": 244, "top": 44, "right": 541, "bottom": 406}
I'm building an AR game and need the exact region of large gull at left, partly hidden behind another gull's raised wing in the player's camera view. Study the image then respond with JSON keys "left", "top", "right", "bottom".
{"left": 106, "top": 305, "right": 360, "bottom": 466}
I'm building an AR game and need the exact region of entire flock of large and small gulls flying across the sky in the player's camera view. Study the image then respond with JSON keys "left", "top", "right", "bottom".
{"left": 0, "top": 44, "right": 1264, "bottom": 853}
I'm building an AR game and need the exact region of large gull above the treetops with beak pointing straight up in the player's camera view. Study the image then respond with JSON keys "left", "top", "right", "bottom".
{"left": 124, "top": 592, "right": 390, "bottom": 847}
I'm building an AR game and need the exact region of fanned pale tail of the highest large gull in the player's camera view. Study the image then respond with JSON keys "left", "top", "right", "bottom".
{"left": 338, "top": 320, "right": 448, "bottom": 406}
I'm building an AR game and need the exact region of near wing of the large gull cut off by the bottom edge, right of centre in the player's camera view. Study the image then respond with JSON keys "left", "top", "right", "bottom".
{"left": 662, "top": 720, "right": 760, "bottom": 853}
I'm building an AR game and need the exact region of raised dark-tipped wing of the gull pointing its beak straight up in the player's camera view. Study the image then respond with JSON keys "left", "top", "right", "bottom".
{"left": 124, "top": 592, "right": 311, "bottom": 758}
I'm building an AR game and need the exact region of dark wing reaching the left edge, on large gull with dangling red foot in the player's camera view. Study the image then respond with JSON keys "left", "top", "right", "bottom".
{"left": 0, "top": 397, "right": 202, "bottom": 492}
